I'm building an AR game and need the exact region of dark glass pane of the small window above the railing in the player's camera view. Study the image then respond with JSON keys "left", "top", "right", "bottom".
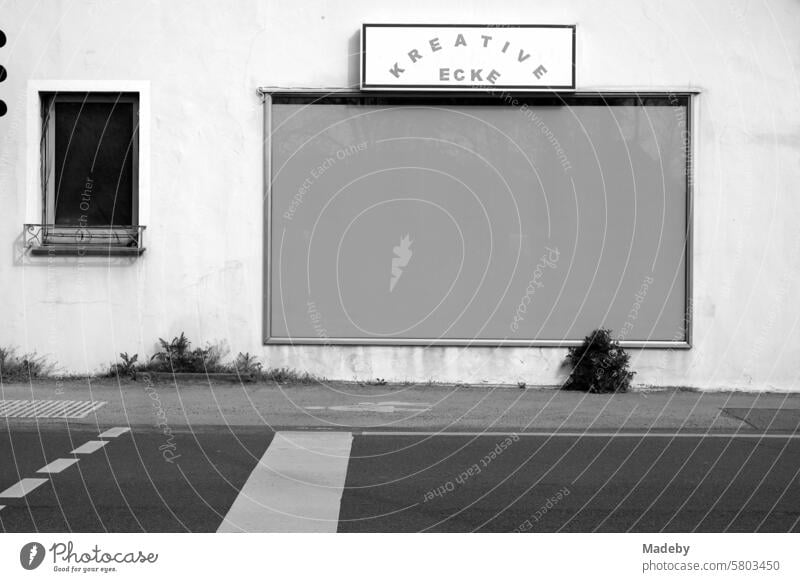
{"left": 53, "top": 101, "right": 134, "bottom": 226}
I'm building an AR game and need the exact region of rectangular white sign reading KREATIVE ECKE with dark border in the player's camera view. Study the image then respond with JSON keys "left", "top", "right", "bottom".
{"left": 361, "top": 24, "right": 575, "bottom": 91}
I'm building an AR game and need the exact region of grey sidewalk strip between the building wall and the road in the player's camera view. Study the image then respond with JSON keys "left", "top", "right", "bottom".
{"left": 0, "top": 380, "right": 800, "bottom": 432}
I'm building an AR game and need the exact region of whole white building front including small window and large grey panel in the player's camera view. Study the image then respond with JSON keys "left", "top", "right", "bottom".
{"left": 0, "top": 0, "right": 800, "bottom": 391}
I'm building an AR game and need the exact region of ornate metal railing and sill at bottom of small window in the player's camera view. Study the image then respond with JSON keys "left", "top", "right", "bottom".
{"left": 24, "top": 224, "right": 146, "bottom": 256}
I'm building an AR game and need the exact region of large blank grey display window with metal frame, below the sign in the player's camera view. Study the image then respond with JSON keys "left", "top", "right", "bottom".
{"left": 264, "top": 91, "right": 692, "bottom": 348}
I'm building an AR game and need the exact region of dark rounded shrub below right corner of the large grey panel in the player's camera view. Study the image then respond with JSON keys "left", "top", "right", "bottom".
{"left": 564, "top": 329, "right": 635, "bottom": 393}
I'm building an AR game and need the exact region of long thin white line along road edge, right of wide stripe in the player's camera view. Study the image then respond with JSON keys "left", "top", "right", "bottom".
{"left": 356, "top": 430, "right": 800, "bottom": 440}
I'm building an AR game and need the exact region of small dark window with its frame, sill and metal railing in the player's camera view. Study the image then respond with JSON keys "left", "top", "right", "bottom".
{"left": 26, "top": 92, "right": 144, "bottom": 254}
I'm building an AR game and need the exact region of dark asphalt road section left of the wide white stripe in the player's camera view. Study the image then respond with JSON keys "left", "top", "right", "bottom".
{"left": 0, "top": 424, "right": 273, "bottom": 532}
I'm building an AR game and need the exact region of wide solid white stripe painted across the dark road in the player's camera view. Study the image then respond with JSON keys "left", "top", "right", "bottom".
{"left": 217, "top": 431, "right": 353, "bottom": 532}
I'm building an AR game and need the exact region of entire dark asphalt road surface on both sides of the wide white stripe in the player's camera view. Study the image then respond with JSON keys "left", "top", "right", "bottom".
{"left": 0, "top": 422, "right": 800, "bottom": 532}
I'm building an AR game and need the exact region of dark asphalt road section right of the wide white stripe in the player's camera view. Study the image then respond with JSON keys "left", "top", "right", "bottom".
{"left": 339, "top": 436, "right": 800, "bottom": 532}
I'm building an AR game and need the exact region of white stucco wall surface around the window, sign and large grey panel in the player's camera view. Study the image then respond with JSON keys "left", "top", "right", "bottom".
{"left": 0, "top": 0, "right": 800, "bottom": 390}
